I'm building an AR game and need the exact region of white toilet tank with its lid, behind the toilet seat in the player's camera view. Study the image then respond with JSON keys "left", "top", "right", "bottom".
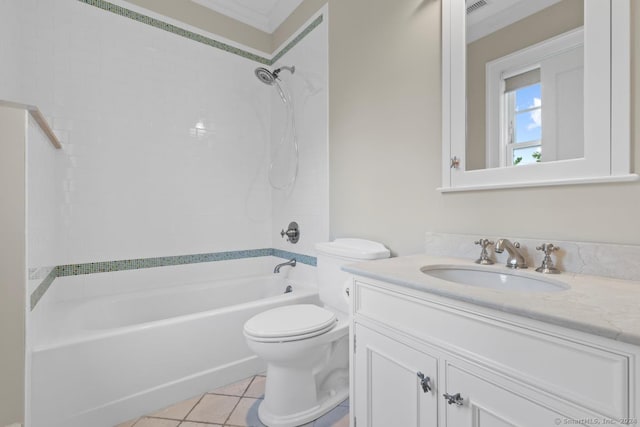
{"left": 316, "top": 239, "right": 391, "bottom": 313}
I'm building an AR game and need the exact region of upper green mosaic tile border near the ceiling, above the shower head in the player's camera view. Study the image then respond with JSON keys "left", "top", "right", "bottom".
{"left": 78, "top": 0, "right": 323, "bottom": 66}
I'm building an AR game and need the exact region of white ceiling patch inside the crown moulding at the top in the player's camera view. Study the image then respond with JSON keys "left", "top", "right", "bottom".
{"left": 191, "top": 0, "right": 303, "bottom": 34}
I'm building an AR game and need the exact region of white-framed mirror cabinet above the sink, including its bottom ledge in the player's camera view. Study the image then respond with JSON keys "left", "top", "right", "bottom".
{"left": 441, "top": 0, "right": 637, "bottom": 191}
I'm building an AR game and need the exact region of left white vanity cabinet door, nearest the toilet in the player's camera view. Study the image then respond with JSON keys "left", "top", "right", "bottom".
{"left": 352, "top": 324, "right": 438, "bottom": 427}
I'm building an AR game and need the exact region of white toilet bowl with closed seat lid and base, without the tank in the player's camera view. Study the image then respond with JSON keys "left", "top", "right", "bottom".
{"left": 244, "top": 304, "right": 349, "bottom": 427}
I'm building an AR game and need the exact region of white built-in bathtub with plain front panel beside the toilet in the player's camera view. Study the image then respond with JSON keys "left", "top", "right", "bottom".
{"left": 30, "top": 260, "right": 319, "bottom": 427}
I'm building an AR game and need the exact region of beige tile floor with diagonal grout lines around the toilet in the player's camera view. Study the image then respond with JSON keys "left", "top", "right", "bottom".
{"left": 116, "top": 375, "right": 349, "bottom": 427}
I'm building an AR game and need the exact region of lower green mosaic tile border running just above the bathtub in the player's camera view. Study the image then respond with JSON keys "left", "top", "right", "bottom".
{"left": 30, "top": 248, "right": 317, "bottom": 310}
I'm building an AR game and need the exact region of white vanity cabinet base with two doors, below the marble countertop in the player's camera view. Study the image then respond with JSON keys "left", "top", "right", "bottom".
{"left": 351, "top": 276, "right": 640, "bottom": 427}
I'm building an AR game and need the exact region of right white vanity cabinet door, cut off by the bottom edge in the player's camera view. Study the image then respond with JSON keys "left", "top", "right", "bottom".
{"left": 440, "top": 364, "right": 591, "bottom": 427}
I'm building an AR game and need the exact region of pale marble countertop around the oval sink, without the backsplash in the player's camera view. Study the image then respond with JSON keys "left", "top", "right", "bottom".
{"left": 343, "top": 255, "right": 640, "bottom": 345}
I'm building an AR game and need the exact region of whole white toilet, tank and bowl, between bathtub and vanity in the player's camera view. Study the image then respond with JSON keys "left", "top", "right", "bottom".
{"left": 244, "top": 239, "right": 390, "bottom": 427}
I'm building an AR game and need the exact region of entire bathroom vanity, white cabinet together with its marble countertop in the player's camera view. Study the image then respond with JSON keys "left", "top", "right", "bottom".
{"left": 346, "top": 255, "right": 640, "bottom": 427}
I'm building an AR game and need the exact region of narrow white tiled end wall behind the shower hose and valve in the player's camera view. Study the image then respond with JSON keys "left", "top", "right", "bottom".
{"left": 269, "top": 8, "right": 329, "bottom": 256}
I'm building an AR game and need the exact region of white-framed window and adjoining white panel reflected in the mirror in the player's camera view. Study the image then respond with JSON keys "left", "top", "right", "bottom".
{"left": 486, "top": 29, "right": 584, "bottom": 168}
